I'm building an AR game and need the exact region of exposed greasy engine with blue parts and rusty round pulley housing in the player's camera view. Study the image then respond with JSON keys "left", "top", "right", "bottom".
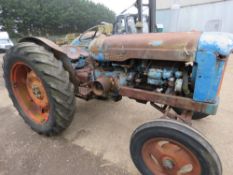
{"left": 73, "top": 58, "right": 192, "bottom": 99}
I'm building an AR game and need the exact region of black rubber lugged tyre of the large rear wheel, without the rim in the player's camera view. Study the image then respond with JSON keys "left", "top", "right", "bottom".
{"left": 3, "top": 42, "right": 75, "bottom": 136}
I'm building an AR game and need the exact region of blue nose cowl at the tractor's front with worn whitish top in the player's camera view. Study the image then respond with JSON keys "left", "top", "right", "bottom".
{"left": 193, "top": 33, "right": 233, "bottom": 103}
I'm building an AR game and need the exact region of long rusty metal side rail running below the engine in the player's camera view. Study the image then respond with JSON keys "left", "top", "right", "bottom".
{"left": 120, "top": 87, "right": 217, "bottom": 114}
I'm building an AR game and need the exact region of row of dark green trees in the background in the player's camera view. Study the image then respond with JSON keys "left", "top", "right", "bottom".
{"left": 0, "top": 0, "right": 115, "bottom": 36}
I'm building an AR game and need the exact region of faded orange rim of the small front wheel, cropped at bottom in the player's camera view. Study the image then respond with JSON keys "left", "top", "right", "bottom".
{"left": 142, "top": 138, "right": 201, "bottom": 175}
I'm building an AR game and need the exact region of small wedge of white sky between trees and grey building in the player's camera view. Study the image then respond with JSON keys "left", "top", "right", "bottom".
{"left": 92, "top": 0, "right": 136, "bottom": 14}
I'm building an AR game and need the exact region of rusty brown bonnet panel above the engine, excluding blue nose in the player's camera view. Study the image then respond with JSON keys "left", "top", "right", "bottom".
{"left": 90, "top": 32, "right": 201, "bottom": 62}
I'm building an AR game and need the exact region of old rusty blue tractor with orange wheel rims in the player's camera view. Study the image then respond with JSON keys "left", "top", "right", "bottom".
{"left": 3, "top": 0, "right": 233, "bottom": 175}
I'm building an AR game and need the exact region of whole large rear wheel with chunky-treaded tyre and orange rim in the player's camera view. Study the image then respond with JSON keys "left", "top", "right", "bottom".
{"left": 3, "top": 42, "right": 75, "bottom": 136}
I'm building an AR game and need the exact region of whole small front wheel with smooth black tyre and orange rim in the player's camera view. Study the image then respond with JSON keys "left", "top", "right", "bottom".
{"left": 130, "top": 119, "right": 222, "bottom": 175}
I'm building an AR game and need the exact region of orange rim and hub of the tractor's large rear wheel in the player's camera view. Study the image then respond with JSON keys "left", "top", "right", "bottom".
{"left": 11, "top": 62, "right": 49, "bottom": 124}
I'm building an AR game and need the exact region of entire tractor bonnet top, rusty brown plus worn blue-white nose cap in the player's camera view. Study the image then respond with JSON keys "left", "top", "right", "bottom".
{"left": 89, "top": 32, "right": 233, "bottom": 62}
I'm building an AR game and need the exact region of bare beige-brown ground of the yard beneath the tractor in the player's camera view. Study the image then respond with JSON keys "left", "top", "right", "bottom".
{"left": 0, "top": 53, "right": 233, "bottom": 175}
